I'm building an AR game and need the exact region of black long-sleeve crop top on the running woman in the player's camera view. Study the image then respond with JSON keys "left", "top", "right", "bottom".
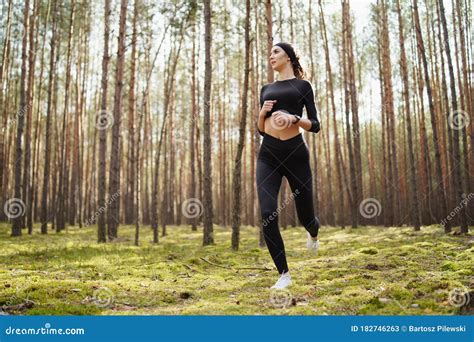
{"left": 257, "top": 78, "right": 321, "bottom": 136}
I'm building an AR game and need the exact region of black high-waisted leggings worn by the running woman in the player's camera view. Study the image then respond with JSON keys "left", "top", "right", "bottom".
{"left": 257, "top": 133, "right": 320, "bottom": 274}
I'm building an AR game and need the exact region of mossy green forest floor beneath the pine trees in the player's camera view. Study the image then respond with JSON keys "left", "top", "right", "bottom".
{"left": 0, "top": 223, "right": 474, "bottom": 315}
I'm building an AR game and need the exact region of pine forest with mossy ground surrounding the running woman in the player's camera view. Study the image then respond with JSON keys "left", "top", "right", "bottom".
{"left": 0, "top": 0, "right": 474, "bottom": 314}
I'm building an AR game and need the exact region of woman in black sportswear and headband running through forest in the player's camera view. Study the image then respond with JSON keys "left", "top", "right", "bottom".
{"left": 256, "top": 43, "right": 320, "bottom": 289}
